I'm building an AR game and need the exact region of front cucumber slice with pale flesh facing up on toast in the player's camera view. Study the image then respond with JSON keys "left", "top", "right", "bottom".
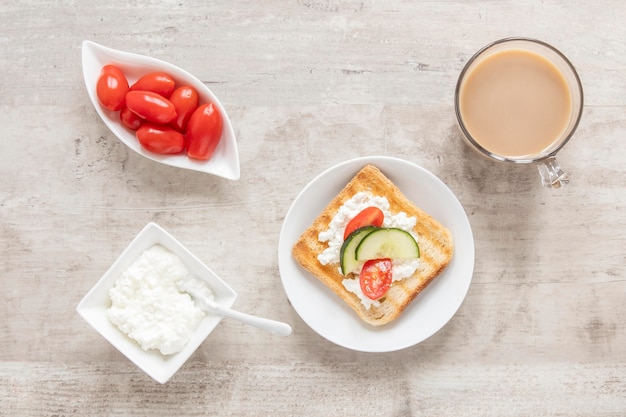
{"left": 356, "top": 227, "right": 420, "bottom": 261}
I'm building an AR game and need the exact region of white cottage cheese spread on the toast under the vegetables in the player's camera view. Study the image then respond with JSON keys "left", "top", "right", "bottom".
{"left": 317, "top": 192, "right": 419, "bottom": 309}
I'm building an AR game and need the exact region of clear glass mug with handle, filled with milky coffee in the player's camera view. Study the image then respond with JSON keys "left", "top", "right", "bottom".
{"left": 454, "top": 38, "right": 583, "bottom": 188}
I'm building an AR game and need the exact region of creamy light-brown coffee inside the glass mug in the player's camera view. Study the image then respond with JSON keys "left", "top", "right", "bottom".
{"left": 458, "top": 49, "right": 573, "bottom": 159}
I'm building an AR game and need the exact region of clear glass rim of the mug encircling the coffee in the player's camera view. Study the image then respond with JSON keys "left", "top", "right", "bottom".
{"left": 454, "top": 36, "right": 584, "bottom": 164}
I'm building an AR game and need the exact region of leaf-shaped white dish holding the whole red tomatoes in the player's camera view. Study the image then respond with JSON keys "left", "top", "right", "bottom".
{"left": 82, "top": 41, "right": 240, "bottom": 180}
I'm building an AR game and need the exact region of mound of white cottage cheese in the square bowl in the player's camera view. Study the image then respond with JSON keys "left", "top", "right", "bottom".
{"left": 107, "top": 245, "right": 212, "bottom": 355}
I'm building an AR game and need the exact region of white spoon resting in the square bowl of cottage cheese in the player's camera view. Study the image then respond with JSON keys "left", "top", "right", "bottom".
{"left": 177, "top": 280, "right": 292, "bottom": 336}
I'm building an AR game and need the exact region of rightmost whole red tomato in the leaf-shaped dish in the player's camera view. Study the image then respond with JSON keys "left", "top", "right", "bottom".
{"left": 186, "top": 103, "right": 222, "bottom": 160}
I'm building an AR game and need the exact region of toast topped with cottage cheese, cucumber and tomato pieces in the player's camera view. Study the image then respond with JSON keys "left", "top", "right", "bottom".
{"left": 292, "top": 165, "right": 454, "bottom": 326}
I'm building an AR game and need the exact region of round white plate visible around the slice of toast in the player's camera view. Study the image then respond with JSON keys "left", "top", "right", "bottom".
{"left": 278, "top": 156, "right": 474, "bottom": 352}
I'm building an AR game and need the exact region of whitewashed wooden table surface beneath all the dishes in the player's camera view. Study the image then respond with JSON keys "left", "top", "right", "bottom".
{"left": 0, "top": 0, "right": 626, "bottom": 417}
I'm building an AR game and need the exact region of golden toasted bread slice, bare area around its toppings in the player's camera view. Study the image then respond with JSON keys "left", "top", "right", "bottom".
{"left": 292, "top": 165, "right": 454, "bottom": 326}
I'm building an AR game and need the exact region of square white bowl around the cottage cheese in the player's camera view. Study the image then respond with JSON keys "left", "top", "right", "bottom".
{"left": 76, "top": 223, "right": 237, "bottom": 384}
